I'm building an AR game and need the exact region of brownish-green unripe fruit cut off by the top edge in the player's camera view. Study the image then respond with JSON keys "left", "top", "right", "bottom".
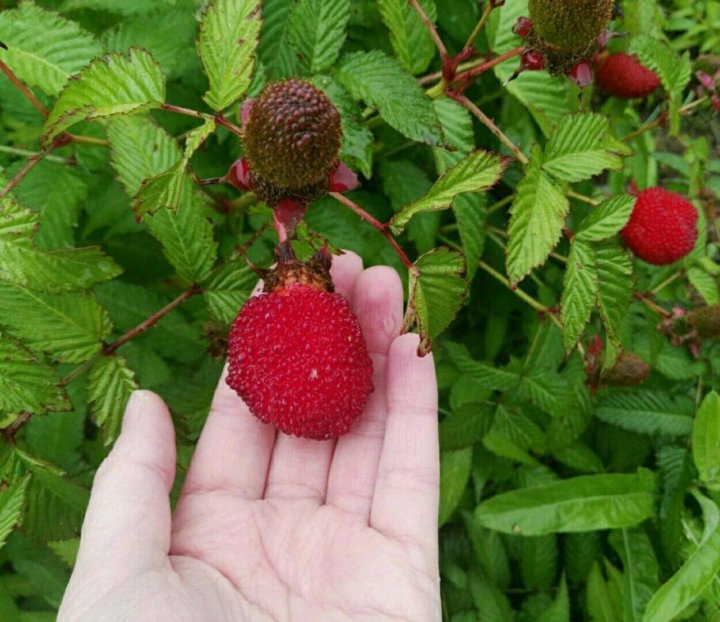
{"left": 528, "top": 0, "right": 613, "bottom": 52}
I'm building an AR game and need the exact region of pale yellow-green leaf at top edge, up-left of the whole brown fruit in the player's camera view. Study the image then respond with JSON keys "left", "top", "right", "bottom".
{"left": 197, "top": 0, "right": 261, "bottom": 112}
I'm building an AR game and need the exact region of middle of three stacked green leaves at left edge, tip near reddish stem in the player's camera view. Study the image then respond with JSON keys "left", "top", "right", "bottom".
{"left": 0, "top": 282, "right": 110, "bottom": 363}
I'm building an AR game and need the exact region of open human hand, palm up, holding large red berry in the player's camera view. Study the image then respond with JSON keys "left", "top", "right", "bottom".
{"left": 58, "top": 253, "right": 440, "bottom": 622}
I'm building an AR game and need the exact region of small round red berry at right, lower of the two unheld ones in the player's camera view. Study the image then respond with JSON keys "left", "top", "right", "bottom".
{"left": 620, "top": 187, "right": 698, "bottom": 265}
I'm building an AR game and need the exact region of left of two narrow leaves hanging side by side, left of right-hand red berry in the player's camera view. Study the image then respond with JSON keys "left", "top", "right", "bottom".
{"left": 560, "top": 237, "right": 598, "bottom": 352}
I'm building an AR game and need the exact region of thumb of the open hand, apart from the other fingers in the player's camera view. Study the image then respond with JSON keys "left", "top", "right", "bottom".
{"left": 63, "top": 391, "right": 175, "bottom": 610}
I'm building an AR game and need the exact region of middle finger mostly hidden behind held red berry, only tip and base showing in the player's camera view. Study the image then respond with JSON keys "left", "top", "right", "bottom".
{"left": 265, "top": 252, "right": 362, "bottom": 502}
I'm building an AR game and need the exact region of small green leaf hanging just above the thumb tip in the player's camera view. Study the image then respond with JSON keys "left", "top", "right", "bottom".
{"left": 88, "top": 355, "right": 138, "bottom": 445}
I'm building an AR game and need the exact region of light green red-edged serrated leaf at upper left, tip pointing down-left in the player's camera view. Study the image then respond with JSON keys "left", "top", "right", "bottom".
{"left": 43, "top": 48, "right": 165, "bottom": 146}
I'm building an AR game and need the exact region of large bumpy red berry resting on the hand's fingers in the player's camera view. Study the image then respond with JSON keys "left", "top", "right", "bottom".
{"left": 227, "top": 264, "right": 373, "bottom": 440}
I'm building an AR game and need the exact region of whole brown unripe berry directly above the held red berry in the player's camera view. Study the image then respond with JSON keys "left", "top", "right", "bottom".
{"left": 243, "top": 79, "right": 342, "bottom": 191}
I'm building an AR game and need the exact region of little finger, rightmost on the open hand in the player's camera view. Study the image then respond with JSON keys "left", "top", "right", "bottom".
{"left": 370, "top": 335, "right": 440, "bottom": 556}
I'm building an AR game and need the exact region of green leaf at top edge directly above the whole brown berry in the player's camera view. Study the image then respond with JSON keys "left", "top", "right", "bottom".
{"left": 288, "top": 0, "right": 350, "bottom": 74}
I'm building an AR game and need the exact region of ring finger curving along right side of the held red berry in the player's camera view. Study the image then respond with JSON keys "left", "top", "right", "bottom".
{"left": 327, "top": 266, "right": 403, "bottom": 520}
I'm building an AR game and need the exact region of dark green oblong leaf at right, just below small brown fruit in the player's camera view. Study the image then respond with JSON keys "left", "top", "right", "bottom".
{"left": 595, "top": 390, "right": 693, "bottom": 436}
